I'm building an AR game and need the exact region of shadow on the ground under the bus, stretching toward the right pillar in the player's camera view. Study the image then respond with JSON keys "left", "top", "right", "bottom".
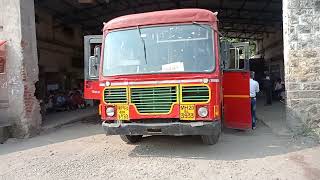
{"left": 129, "top": 123, "right": 316, "bottom": 160}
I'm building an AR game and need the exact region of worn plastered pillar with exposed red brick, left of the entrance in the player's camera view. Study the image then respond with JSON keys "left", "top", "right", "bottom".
{"left": 0, "top": 0, "right": 41, "bottom": 137}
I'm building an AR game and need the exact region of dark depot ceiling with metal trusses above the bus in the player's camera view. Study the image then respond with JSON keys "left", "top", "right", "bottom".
{"left": 35, "top": 0, "right": 282, "bottom": 38}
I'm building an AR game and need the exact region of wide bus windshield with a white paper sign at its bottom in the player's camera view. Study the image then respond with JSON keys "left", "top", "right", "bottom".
{"left": 103, "top": 24, "right": 215, "bottom": 76}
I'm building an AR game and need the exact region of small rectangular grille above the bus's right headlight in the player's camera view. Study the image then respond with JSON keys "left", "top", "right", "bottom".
{"left": 182, "top": 86, "right": 209, "bottom": 102}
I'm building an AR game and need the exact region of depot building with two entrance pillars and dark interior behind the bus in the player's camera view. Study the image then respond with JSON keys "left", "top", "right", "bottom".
{"left": 0, "top": 0, "right": 320, "bottom": 137}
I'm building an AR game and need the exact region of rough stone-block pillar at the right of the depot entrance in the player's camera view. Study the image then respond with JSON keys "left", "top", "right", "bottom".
{"left": 283, "top": 0, "right": 320, "bottom": 136}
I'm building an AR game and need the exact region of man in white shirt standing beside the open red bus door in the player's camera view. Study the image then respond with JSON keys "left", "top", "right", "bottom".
{"left": 250, "top": 71, "right": 260, "bottom": 129}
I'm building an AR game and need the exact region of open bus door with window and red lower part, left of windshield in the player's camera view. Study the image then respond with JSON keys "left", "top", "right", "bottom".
{"left": 84, "top": 35, "right": 102, "bottom": 100}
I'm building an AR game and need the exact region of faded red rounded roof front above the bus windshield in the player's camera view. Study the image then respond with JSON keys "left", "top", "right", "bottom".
{"left": 103, "top": 9, "right": 218, "bottom": 31}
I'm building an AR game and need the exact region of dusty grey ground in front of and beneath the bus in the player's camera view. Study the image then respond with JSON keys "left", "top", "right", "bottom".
{"left": 0, "top": 112, "right": 320, "bottom": 180}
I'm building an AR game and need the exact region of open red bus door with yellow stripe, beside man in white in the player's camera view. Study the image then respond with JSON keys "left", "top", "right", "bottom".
{"left": 221, "top": 42, "right": 252, "bottom": 129}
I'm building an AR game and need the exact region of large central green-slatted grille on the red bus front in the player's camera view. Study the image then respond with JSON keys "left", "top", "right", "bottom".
{"left": 131, "top": 86, "right": 177, "bottom": 113}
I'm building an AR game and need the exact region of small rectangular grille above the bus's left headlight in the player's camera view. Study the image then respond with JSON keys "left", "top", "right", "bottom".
{"left": 104, "top": 88, "right": 127, "bottom": 103}
